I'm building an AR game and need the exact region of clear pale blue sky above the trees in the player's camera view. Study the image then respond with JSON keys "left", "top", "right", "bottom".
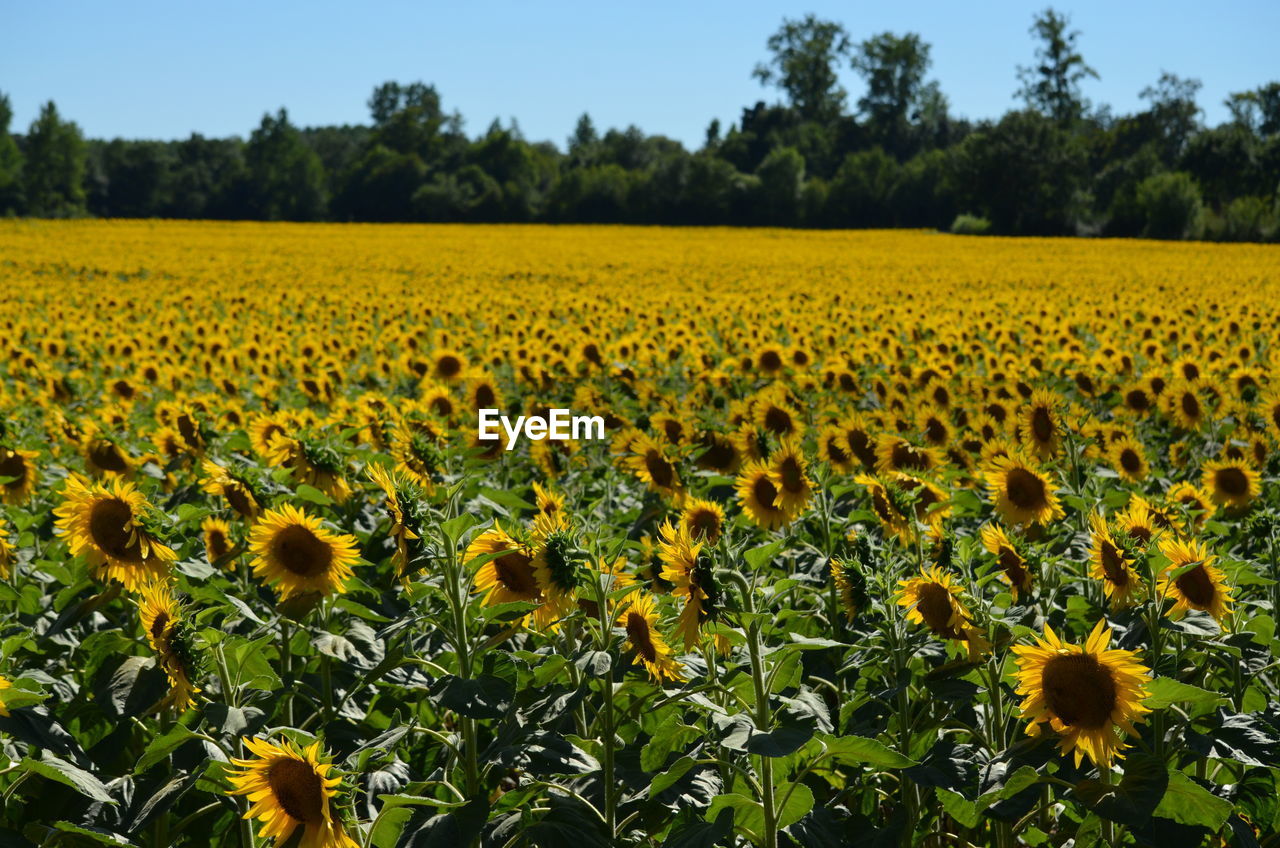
{"left": 0, "top": 0, "right": 1280, "bottom": 147}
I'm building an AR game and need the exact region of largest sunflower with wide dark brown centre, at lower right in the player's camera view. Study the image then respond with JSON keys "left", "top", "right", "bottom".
{"left": 1014, "top": 621, "right": 1151, "bottom": 769}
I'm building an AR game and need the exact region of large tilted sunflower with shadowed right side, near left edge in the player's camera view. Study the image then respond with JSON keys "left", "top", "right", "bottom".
{"left": 54, "top": 477, "right": 178, "bottom": 592}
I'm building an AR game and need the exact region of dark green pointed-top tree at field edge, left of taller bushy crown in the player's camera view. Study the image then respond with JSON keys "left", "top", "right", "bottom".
{"left": 244, "top": 109, "right": 325, "bottom": 220}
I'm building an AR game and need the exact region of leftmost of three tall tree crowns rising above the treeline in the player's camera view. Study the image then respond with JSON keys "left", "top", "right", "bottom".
{"left": 751, "top": 14, "right": 851, "bottom": 122}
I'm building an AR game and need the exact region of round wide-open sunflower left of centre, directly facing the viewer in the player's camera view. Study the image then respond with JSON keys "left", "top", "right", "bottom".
{"left": 248, "top": 503, "right": 360, "bottom": 599}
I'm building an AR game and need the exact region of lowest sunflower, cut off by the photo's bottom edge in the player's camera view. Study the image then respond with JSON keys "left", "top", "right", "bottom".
{"left": 227, "top": 739, "right": 360, "bottom": 848}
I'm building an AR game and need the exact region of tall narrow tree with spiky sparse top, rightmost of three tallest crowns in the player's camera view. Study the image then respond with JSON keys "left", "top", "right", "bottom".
{"left": 1018, "top": 8, "right": 1098, "bottom": 127}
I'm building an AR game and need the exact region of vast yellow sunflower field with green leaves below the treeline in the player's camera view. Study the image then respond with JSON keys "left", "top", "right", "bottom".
{"left": 0, "top": 222, "right": 1280, "bottom": 848}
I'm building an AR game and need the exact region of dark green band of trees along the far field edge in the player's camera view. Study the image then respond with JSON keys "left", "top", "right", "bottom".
{"left": 0, "top": 9, "right": 1280, "bottom": 241}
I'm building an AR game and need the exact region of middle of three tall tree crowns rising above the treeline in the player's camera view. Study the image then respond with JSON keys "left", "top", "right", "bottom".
{"left": 852, "top": 32, "right": 945, "bottom": 156}
